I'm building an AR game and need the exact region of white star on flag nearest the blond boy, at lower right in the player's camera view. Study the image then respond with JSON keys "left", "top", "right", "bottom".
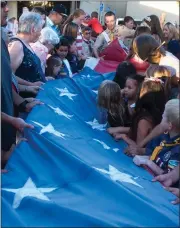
{"left": 94, "top": 165, "right": 143, "bottom": 188}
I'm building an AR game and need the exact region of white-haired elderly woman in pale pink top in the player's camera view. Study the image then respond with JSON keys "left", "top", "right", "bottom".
{"left": 31, "top": 27, "right": 59, "bottom": 72}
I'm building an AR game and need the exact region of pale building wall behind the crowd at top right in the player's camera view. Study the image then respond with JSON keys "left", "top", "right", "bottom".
{"left": 80, "top": 0, "right": 179, "bottom": 24}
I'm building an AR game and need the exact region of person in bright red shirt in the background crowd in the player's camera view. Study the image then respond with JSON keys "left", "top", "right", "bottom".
{"left": 88, "top": 12, "right": 103, "bottom": 37}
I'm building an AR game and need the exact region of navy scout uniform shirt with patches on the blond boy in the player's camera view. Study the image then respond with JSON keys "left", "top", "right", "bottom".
{"left": 146, "top": 134, "right": 180, "bottom": 172}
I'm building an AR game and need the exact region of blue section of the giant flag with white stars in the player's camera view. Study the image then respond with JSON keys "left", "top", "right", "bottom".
{"left": 1, "top": 68, "right": 179, "bottom": 227}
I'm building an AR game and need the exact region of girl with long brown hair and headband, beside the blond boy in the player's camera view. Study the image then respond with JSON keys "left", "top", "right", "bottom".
{"left": 116, "top": 78, "right": 166, "bottom": 145}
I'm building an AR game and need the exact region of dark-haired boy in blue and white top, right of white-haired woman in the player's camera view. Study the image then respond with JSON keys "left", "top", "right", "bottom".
{"left": 54, "top": 36, "right": 73, "bottom": 78}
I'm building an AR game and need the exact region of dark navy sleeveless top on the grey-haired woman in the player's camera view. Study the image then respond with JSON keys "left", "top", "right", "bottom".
{"left": 11, "top": 38, "right": 46, "bottom": 82}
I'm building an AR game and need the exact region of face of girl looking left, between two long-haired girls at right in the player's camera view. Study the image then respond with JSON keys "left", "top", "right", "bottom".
{"left": 124, "top": 79, "right": 138, "bottom": 99}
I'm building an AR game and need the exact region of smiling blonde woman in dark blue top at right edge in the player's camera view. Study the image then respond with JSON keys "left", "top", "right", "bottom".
{"left": 163, "top": 22, "right": 180, "bottom": 59}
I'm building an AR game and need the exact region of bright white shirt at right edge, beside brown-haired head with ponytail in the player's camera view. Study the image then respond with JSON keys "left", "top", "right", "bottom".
{"left": 159, "top": 51, "right": 179, "bottom": 78}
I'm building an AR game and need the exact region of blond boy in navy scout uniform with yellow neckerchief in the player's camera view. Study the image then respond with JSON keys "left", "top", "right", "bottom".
{"left": 133, "top": 99, "right": 180, "bottom": 175}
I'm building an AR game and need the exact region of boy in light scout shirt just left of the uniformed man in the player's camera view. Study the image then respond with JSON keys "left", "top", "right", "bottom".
{"left": 82, "top": 27, "right": 94, "bottom": 58}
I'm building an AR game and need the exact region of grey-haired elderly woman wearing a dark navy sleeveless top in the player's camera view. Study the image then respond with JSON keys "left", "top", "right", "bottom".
{"left": 9, "top": 12, "right": 46, "bottom": 82}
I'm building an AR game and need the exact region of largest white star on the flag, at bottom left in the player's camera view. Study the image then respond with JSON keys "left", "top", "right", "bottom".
{"left": 2, "top": 178, "right": 57, "bottom": 209}
